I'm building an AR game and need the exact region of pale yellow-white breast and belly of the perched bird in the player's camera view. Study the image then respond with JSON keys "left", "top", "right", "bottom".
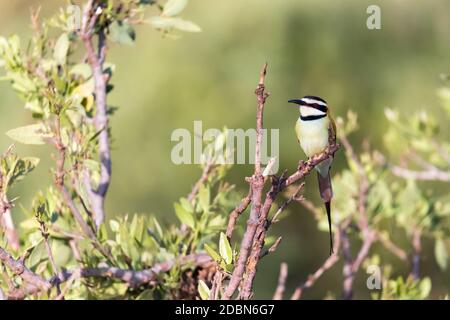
{"left": 295, "top": 117, "right": 330, "bottom": 158}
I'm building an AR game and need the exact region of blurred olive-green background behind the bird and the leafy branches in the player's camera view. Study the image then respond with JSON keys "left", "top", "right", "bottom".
{"left": 0, "top": 0, "right": 450, "bottom": 299}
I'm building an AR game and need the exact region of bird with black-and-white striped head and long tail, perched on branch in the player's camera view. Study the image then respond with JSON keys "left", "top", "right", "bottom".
{"left": 288, "top": 95, "right": 336, "bottom": 255}
